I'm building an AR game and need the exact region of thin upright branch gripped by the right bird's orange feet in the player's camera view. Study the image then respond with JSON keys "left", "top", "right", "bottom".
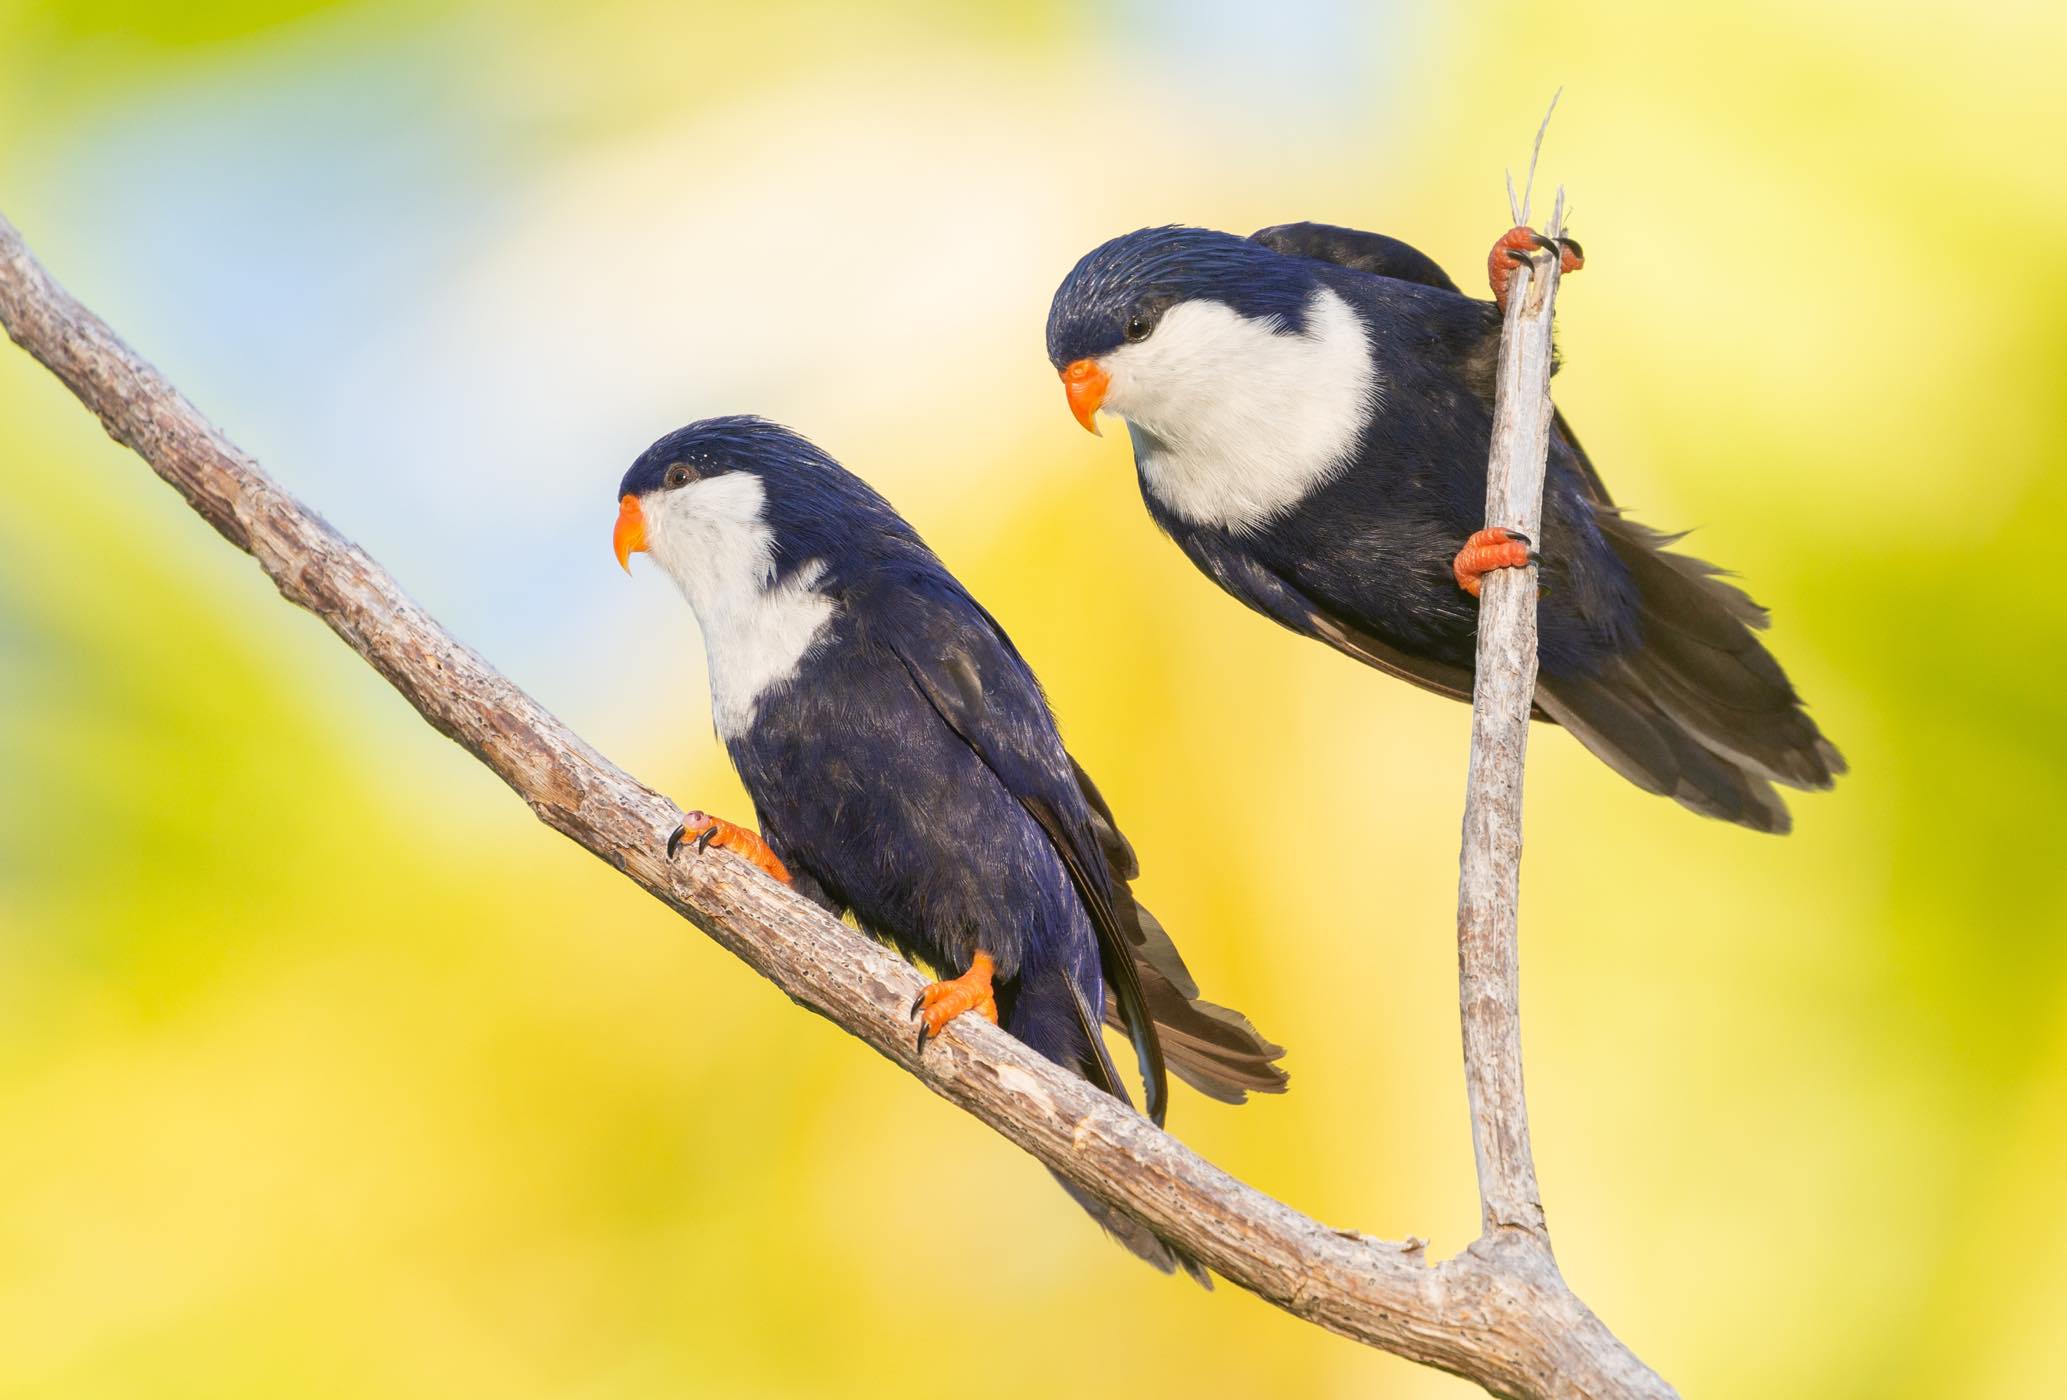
{"left": 1457, "top": 188, "right": 1565, "bottom": 1249}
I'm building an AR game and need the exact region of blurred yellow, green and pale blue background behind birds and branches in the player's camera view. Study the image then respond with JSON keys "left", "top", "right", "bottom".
{"left": 0, "top": 0, "right": 2067, "bottom": 1400}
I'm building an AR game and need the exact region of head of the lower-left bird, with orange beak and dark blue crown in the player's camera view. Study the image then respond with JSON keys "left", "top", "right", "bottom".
{"left": 616, "top": 416, "right": 924, "bottom": 591}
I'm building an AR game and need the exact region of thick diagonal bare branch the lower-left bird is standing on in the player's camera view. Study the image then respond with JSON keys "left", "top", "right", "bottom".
{"left": 0, "top": 209, "right": 1672, "bottom": 1398}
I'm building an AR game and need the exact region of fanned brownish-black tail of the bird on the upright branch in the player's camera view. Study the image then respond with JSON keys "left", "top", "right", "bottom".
{"left": 1536, "top": 509, "right": 1846, "bottom": 833}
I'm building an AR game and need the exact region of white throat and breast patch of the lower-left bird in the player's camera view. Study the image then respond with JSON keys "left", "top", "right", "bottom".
{"left": 643, "top": 471, "right": 833, "bottom": 740}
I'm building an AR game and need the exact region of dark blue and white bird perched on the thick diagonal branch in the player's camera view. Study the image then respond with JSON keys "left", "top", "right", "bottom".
{"left": 614, "top": 418, "right": 1286, "bottom": 1282}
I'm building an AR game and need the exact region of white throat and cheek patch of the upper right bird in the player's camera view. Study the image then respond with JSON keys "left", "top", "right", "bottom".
{"left": 1100, "top": 287, "right": 1383, "bottom": 534}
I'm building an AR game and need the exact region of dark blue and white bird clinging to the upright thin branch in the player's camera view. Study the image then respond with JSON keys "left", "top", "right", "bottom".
{"left": 1048, "top": 223, "right": 1844, "bottom": 831}
